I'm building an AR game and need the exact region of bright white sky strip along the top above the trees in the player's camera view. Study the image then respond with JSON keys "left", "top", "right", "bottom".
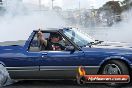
{"left": 23, "top": 0, "right": 123, "bottom": 9}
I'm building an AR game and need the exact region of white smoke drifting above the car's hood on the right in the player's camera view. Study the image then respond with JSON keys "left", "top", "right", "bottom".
{"left": 88, "top": 10, "right": 132, "bottom": 43}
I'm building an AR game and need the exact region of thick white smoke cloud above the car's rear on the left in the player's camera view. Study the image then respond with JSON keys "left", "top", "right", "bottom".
{"left": 0, "top": 0, "right": 65, "bottom": 42}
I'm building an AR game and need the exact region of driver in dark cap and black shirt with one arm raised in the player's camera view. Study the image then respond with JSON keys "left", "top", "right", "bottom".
{"left": 37, "top": 30, "right": 65, "bottom": 51}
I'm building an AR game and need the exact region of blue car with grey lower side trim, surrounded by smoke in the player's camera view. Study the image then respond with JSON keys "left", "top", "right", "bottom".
{"left": 0, "top": 28, "right": 132, "bottom": 86}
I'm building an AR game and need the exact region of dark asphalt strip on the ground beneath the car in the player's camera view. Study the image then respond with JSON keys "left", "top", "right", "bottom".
{"left": 3, "top": 80, "right": 132, "bottom": 88}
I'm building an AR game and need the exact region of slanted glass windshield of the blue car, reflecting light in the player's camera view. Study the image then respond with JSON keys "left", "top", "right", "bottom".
{"left": 63, "top": 28, "right": 95, "bottom": 47}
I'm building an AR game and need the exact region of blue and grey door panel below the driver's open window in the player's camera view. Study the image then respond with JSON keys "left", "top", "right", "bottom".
{"left": 40, "top": 51, "right": 84, "bottom": 79}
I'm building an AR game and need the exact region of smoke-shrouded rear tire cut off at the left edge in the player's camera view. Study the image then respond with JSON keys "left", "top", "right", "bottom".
{"left": 0, "top": 64, "right": 8, "bottom": 87}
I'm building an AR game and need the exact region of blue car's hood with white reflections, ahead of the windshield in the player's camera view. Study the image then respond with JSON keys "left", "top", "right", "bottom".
{"left": 82, "top": 42, "right": 132, "bottom": 53}
